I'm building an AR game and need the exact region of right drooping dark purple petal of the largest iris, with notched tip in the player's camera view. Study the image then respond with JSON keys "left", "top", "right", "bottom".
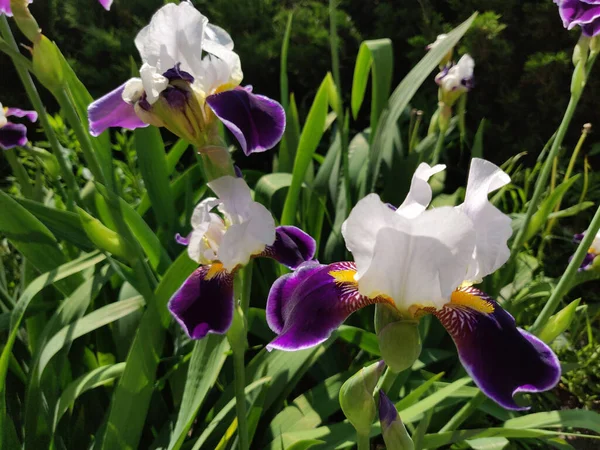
{"left": 425, "top": 287, "right": 561, "bottom": 410}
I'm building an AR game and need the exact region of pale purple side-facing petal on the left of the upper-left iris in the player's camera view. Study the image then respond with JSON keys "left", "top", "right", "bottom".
{"left": 88, "top": 83, "right": 148, "bottom": 136}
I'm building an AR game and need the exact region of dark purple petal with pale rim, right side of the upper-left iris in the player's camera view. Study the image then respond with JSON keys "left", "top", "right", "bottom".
{"left": 206, "top": 87, "right": 285, "bottom": 155}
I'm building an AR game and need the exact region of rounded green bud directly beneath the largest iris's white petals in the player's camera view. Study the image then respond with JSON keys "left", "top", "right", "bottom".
{"left": 375, "top": 304, "right": 421, "bottom": 373}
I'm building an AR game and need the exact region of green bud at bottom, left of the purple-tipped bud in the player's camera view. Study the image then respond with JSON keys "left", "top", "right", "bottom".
{"left": 340, "top": 361, "right": 385, "bottom": 436}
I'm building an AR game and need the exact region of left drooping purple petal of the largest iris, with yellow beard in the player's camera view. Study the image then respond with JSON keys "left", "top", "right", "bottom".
{"left": 267, "top": 261, "right": 385, "bottom": 351}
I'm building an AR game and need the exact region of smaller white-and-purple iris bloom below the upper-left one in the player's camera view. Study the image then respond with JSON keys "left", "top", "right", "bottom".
{"left": 169, "top": 176, "right": 315, "bottom": 339}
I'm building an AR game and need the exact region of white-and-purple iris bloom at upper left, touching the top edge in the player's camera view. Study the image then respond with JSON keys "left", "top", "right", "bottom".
{"left": 88, "top": 1, "right": 285, "bottom": 155}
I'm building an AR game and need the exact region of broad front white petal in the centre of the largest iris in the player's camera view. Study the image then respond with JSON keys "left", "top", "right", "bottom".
{"left": 357, "top": 208, "right": 474, "bottom": 311}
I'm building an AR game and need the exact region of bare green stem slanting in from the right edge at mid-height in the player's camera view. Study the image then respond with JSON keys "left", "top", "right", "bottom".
{"left": 530, "top": 207, "right": 600, "bottom": 334}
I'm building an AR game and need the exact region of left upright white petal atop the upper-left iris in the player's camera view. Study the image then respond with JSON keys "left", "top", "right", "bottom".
{"left": 135, "top": 1, "right": 208, "bottom": 76}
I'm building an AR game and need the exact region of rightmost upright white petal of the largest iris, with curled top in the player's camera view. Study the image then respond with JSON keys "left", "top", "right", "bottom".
{"left": 457, "top": 158, "right": 512, "bottom": 282}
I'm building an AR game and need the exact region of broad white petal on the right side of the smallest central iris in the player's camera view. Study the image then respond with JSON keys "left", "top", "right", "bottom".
{"left": 217, "top": 202, "right": 275, "bottom": 271}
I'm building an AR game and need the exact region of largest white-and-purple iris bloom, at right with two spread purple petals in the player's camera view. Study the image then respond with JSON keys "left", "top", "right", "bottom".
{"left": 267, "top": 159, "right": 560, "bottom": 409}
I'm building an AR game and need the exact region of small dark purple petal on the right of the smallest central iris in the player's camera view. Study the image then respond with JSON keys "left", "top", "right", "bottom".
{"left": 260, "top": 226, "right": 317, "bottom": 269}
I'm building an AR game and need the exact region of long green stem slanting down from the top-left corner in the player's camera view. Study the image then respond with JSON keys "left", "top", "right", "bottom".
{"left": 0, "top": 15, "right": 79, "bottom": 211}
